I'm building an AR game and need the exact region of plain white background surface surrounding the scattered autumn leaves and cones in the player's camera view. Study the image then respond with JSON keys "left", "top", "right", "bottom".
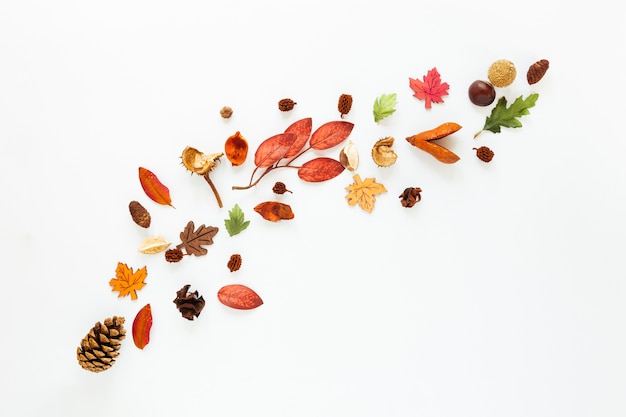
{"left": 0, "top": 0, "right": 626, "bottom": 417}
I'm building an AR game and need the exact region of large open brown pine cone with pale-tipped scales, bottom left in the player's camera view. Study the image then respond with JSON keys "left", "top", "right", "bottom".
{"left": 76, "top": 316, "right": 126, "bottom": 372}
